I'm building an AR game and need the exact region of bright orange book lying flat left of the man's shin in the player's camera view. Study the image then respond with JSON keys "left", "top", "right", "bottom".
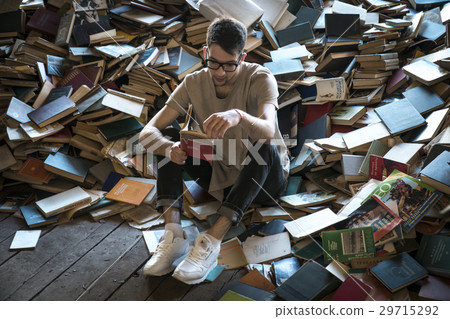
{"left": 105, "top": 178, "right": 155, "bottom": 206}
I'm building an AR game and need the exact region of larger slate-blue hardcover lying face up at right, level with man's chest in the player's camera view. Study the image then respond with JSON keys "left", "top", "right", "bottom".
{"left": 375, "top": 99, "right": 426, "bottom": 135}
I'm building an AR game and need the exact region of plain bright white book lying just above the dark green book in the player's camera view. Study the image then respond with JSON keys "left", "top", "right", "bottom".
{"left": 284, "top": 208, "right": 347, "bottom": 238}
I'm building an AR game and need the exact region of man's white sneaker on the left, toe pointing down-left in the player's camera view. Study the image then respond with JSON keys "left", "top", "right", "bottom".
{"left": 144, "top": 230, "right": 189, "bottom": 276}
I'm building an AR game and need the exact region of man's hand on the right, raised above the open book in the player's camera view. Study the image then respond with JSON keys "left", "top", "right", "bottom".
{"left": 203, "top": 110, "right": 241, "bottom": 139}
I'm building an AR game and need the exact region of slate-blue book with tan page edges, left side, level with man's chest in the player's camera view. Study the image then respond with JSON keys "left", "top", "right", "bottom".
{"left": 28, "top": 96, "right": 77, "bottom": 127}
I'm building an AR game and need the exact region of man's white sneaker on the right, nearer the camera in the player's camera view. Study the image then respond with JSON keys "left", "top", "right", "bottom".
{"left": 172, "top": 234, "right": 220, "bottom": 285}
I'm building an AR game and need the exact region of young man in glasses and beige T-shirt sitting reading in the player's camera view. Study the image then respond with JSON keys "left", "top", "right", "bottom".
{"left": 140, "top": 18, "right": 289, "bottom": 284}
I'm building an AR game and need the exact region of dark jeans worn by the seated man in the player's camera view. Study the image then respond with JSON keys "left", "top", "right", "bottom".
{"left": 156, "top": 128, "right": 286, "bottom": 225}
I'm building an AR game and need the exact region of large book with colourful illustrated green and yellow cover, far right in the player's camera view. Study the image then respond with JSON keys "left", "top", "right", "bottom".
{"left": 362, "top": 170, "right": 442, "bottom": 232}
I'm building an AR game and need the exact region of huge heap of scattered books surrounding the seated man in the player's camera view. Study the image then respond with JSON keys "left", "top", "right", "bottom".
{"left": 0, "top": 0, "right": 450, "bottom": 300}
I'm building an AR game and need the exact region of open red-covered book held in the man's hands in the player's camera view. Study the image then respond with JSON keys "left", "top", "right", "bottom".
{"left": 180, "top": 104, "right": 215, "bottom": 162}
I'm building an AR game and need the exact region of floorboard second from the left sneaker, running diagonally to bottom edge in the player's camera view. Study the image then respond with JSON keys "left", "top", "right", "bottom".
{"left": 33, "top": 219, "right": 145, "bottom": 300}
